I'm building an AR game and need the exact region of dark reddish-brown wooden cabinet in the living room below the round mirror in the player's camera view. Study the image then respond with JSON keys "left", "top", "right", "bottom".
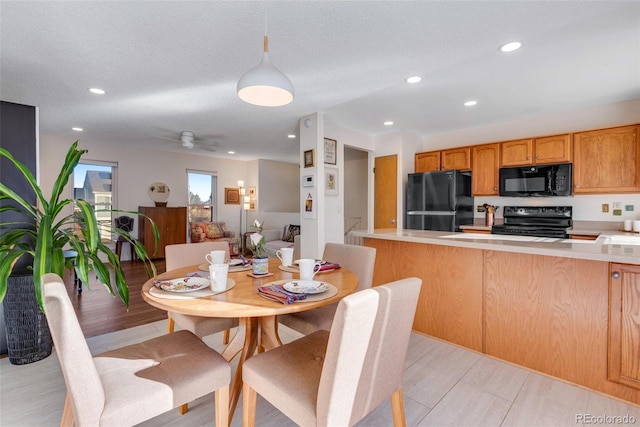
{"left": 138, "top": 206, "right": 187, "bottom": 259}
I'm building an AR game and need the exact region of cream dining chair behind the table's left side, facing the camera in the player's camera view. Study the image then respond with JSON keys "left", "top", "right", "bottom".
{"left": 164, "top": 242, "right": 238, "bottom": 344}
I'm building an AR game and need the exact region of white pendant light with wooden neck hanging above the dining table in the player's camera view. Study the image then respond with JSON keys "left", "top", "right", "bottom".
{"left": 238, "top": 14, "right": 293, "bottom": 107}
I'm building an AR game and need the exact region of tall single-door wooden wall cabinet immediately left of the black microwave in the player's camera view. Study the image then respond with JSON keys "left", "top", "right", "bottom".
{"left": 471, "top": 143, "right": 500, "bottom": 196}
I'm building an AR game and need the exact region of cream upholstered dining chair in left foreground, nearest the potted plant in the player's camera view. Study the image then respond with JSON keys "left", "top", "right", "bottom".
{"left": 42, "top": 273, "right": 231, "bottom": 427}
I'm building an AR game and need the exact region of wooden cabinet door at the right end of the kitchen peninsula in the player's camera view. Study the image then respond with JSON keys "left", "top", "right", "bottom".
{"left": 608, "top": 263, "right": 640, "bottom": 389}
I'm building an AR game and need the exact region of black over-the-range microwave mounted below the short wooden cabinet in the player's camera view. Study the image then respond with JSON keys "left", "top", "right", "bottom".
{"left": 500, "top": 163, "right": 572, "bottom": 197}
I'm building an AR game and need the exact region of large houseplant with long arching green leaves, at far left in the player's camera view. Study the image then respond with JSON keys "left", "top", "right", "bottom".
{"left": 0, "top": 141, "right": 159, "bottom": 309}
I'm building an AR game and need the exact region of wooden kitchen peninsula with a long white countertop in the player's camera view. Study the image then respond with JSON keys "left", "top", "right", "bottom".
{"left": 353, "top": 229, "right": 640, "bottom": 404}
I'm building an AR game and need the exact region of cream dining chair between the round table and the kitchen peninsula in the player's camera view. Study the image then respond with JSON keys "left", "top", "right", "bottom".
{"left": 278, "top": 243, "right": 376, "bottom": 335}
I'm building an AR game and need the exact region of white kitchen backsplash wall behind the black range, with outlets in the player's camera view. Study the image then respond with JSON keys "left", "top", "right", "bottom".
{"left": 474, "top": 194, "right": 640, "bottom": 222}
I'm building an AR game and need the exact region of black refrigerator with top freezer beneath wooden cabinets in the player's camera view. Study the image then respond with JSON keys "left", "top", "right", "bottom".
{"left": 405, "top": 171, "right": 473, "bottom": 231}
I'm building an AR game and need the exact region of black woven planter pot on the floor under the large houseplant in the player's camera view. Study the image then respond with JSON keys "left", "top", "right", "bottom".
{"left": 3, "top": 274, "right": 53, "bottom": 365}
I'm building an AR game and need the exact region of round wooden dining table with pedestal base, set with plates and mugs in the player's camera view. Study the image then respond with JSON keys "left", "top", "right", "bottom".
{"left": 142, "top": 259, "right": 358, "bottom": 422}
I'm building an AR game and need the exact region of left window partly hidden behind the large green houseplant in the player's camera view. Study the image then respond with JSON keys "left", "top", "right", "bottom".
{"left": 73, "top": 161, "right": 118, "bottom": 243}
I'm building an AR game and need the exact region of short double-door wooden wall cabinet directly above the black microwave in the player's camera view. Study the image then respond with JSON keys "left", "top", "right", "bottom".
{"left": 500, "top": 134, "right": 572, "bottom": 166}
